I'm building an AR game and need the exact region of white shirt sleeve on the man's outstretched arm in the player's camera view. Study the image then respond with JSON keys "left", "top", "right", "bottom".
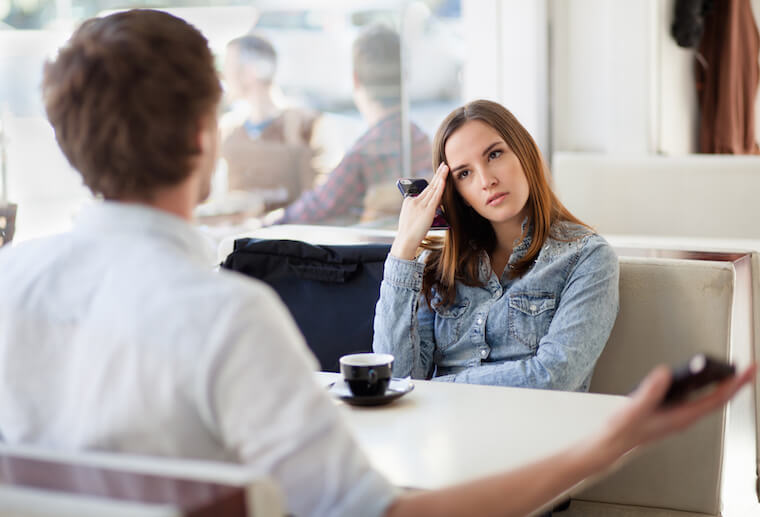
{"left": 205, "top": 282, "right": 397, "bottom": 517}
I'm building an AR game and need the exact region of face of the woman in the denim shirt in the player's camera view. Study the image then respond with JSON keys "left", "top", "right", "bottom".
{"left": 444, "top": 120, "right": 530, "bottom": 225}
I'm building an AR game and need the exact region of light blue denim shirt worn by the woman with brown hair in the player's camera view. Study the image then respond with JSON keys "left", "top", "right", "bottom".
{"left": 372, "top": 222, "right": 619, "bottom": 391}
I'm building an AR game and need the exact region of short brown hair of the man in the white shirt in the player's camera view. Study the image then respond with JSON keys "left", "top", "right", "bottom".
{"left": 42, "top": 9, "right": 222, "bottom": 199}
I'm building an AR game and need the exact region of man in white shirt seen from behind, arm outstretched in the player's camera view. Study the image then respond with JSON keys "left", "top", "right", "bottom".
{"left": 0, "top": 10, "right": 754, "bottom": 516}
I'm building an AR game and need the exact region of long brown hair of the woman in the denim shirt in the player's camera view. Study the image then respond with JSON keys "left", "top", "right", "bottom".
{"left": 422, "top": 100, "right": 583, "bottom": 306}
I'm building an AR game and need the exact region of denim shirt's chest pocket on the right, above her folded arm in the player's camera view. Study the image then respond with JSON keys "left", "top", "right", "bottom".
{"left": 509, "top": 291, "right": 556, "bottom": 353}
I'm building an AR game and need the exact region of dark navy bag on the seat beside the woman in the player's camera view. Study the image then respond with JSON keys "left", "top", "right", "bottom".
{"left": 222, "top": 239, "right": 390, "bottom": 372}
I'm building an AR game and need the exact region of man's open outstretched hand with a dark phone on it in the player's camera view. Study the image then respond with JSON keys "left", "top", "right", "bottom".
{"left": 605, "top": 364, "right": 757, "bottom": 455}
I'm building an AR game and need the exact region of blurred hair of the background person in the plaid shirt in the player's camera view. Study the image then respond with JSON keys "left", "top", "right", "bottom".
{"left": 353, "top": 25, "right": 401, "bottom": 106}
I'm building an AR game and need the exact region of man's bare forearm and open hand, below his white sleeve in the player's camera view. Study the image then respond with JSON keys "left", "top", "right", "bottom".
{"left": 386, "top": 365, "right": 756, "bottom": 517}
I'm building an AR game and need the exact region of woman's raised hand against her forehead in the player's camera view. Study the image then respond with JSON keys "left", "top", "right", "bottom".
{"left": 391, "top": 163, "right": 449, "bottom": 260}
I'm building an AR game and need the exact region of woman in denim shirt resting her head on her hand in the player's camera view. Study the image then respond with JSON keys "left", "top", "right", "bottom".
{"left": 373, "top": 100, "right": 618, "bottom": 391}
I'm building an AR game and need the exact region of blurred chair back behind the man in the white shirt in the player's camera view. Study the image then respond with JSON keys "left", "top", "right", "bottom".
{"left": 0, "top": 444, "right": 285, "bottom": 517}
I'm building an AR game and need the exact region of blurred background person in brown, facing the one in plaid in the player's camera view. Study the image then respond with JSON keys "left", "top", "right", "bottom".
{"left": 221, "top": 34, "right": 317, "bottom": 209}
